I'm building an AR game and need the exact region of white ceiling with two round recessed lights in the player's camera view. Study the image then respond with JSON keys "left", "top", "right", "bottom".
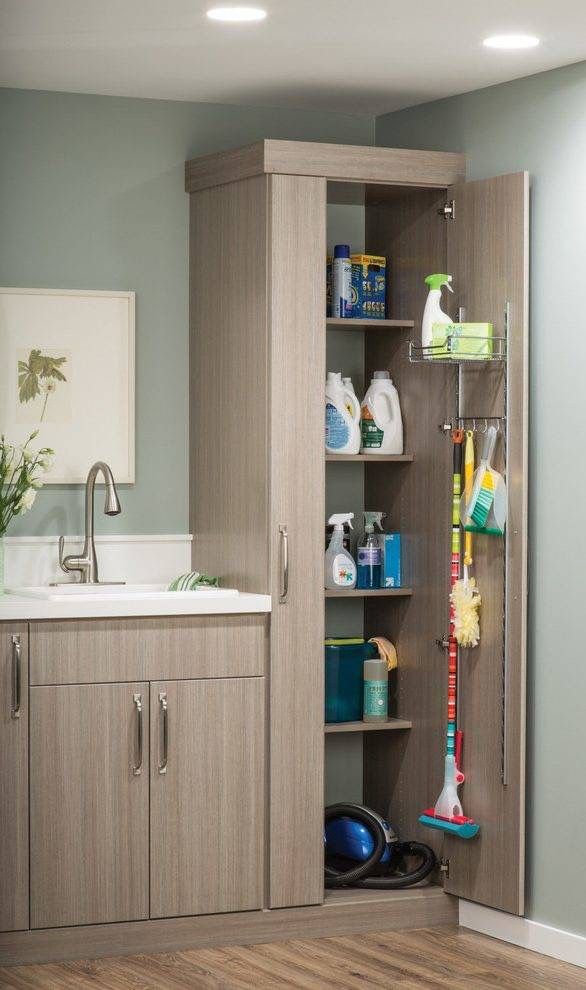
{"left": 0, "top": 0, "right": 586, "bottom": 114}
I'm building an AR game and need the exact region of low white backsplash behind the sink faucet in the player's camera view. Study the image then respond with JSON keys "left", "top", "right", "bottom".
{"left": 5, "top": 534, "right": 192, "bottom": 588}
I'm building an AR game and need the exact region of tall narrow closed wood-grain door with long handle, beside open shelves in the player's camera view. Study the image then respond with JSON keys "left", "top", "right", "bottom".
{"left": 269, "top": 175, "right": 326, "bottom": 908}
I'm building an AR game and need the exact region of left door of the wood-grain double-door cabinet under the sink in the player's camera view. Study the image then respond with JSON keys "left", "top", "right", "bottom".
{"left": 30, "top": 683, "right": 149, "bottom": 928}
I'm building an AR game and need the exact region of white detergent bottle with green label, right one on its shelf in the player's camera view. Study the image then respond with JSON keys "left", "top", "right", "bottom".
{"left": 360, "top": 371, "right": 403, "bottom": 454}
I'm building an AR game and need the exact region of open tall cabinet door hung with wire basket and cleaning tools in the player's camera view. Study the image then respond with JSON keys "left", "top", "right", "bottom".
{"left": 444, "top": 172, "right": 529, "bottom": 914}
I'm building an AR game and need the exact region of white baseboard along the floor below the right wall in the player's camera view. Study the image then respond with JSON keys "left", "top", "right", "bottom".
{"left": 460, "top": 900, "right": 586, "bottom": 968}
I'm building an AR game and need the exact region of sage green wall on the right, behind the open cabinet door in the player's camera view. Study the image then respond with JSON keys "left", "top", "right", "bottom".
{"left": 376, "top": 56, "right": 586, "bottom": 934}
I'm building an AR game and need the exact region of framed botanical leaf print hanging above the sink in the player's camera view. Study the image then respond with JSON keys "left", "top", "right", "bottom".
{"left": 0, "top": 288, "right": 134, "bottom": 484}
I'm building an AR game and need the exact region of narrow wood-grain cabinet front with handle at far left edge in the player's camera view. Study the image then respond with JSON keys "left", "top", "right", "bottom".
{"left": 0, "top": 623, "right": 29, "bottom": 931}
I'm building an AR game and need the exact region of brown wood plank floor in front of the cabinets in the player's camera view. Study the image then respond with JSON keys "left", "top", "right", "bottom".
{"left": 0, "top": 928, "right": 586, "bottom": 990}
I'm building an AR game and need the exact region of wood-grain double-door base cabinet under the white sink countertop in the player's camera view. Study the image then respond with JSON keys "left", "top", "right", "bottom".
{"left": 21, "top": 615, "right": 267, "bottom": 929}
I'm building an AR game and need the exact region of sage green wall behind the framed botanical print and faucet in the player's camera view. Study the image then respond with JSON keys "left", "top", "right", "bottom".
{"left": 0, "top": 89, "right": 374, "bottom": 535}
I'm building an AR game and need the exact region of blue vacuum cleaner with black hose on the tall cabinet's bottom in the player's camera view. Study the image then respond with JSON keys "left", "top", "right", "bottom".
{"left": 324, "top": 804, "right": 436, "bottom": 890}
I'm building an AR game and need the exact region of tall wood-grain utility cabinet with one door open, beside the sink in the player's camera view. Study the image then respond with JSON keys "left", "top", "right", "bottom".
{"left": 186, "top": 141, "right": 528, "bottom": 913}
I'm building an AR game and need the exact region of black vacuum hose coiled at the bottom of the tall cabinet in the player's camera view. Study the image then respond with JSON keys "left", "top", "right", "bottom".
{"left": 325, "top": 804, "right": 436, "bottom": 890}
